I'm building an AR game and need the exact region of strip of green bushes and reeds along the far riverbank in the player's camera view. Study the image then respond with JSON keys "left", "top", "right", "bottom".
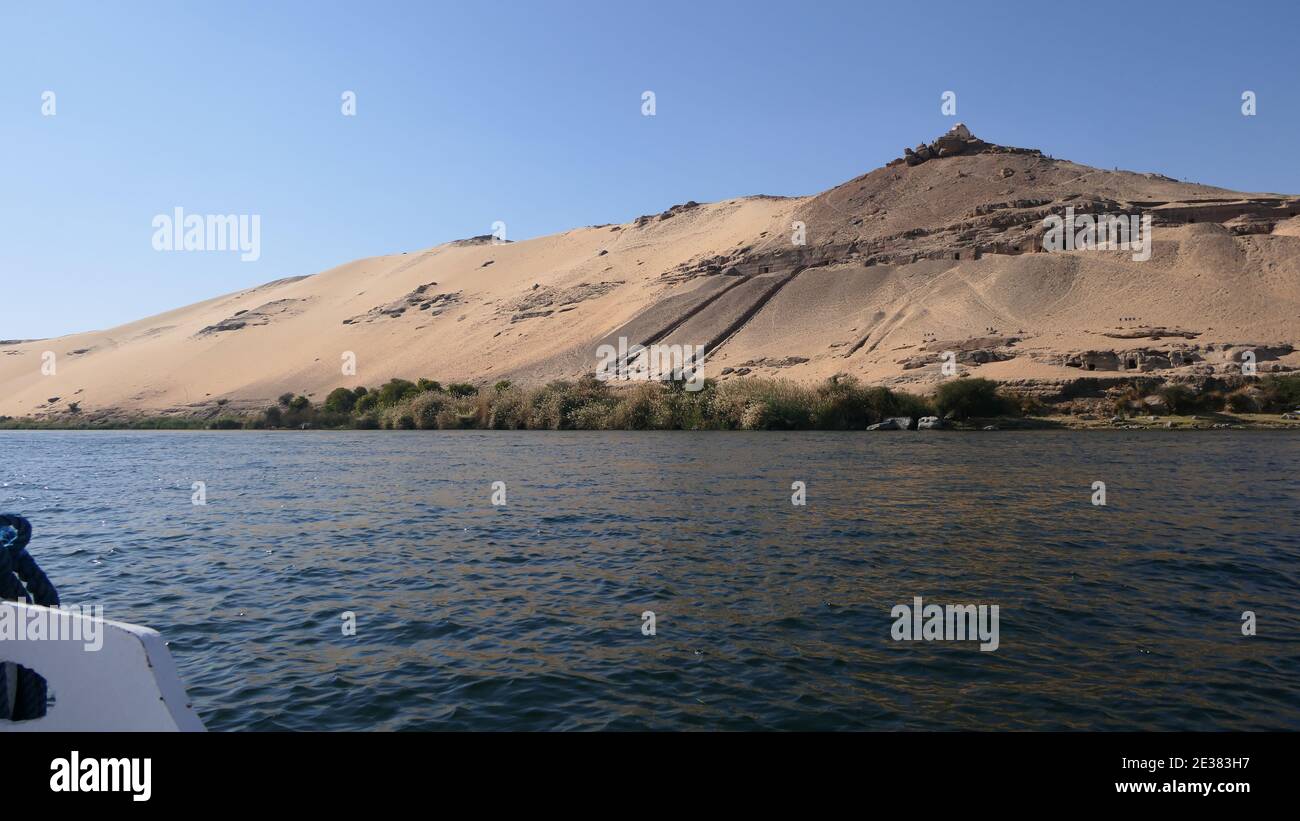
{"left": 0, "top": 374, "right": 1300, "bottom": 430}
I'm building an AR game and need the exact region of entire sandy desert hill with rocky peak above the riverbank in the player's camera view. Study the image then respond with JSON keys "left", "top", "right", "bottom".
{"left": 0, "top": 127, "right": 1300, "bottom": 416}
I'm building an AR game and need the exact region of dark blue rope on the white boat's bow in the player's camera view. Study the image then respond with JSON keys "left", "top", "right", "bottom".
{"left": 0, "top": 513, "right": 59, "bottom": 721}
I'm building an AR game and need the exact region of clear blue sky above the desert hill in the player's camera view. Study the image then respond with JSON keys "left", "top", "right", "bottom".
{"left": 0, "top": 0, "right": 1300, "bottom": 339}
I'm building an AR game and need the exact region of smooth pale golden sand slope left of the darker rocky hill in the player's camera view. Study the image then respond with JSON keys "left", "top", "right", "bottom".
{"left": 0, "top": 197, "right": 794, "bottom": 416}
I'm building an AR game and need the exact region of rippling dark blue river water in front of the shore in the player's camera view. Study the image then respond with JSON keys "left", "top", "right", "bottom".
{"left": 0, "top": 431, "right": 1300, "bottom": 730}
